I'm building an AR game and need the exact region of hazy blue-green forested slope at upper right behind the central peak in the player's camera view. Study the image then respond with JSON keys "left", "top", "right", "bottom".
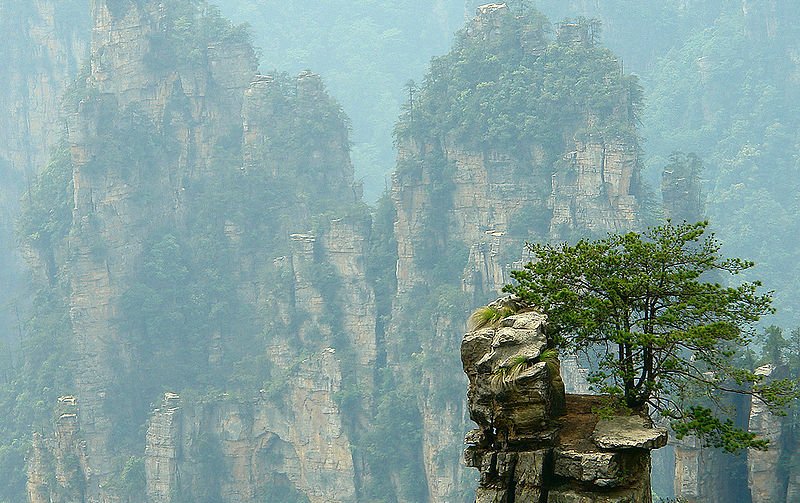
{"left": 536, "top": 0, "right": 800, "bottom": 326}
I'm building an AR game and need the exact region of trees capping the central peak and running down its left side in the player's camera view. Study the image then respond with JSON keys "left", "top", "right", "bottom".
{"left": 356, "top": 6, "right": 639, "bottom": 501}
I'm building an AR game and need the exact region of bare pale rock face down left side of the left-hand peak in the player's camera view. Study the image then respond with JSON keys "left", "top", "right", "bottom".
{"left": 57, "top": 2, "right": 255, "bottom": 501}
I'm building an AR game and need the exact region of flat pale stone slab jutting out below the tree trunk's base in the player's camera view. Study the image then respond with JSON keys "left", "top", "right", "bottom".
{"left": 592, "top": 415, "right": 668, "bottom": 450}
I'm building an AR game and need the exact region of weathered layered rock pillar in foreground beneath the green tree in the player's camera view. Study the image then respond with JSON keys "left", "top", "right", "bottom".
{"left": 461, "top": 302, "right": 667, "bottom": 503}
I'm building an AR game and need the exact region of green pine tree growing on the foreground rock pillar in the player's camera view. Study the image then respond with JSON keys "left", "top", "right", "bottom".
{"left": 506, "top": 222, "right": 798, "bottom": 452}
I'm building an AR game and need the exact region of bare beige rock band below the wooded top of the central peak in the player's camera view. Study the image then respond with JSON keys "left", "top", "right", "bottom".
{"left": 392, "top": 138, "right": 638, "bottom": 296}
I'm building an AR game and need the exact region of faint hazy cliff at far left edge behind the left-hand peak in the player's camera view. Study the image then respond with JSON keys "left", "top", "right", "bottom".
{"left": 0, "top": 0, "right": 89, "bottom": 334}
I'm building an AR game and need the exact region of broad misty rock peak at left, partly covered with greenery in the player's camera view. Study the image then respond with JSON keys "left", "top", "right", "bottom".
{"left": 24, "top": 1, "right": 368, "bottom": 502}
